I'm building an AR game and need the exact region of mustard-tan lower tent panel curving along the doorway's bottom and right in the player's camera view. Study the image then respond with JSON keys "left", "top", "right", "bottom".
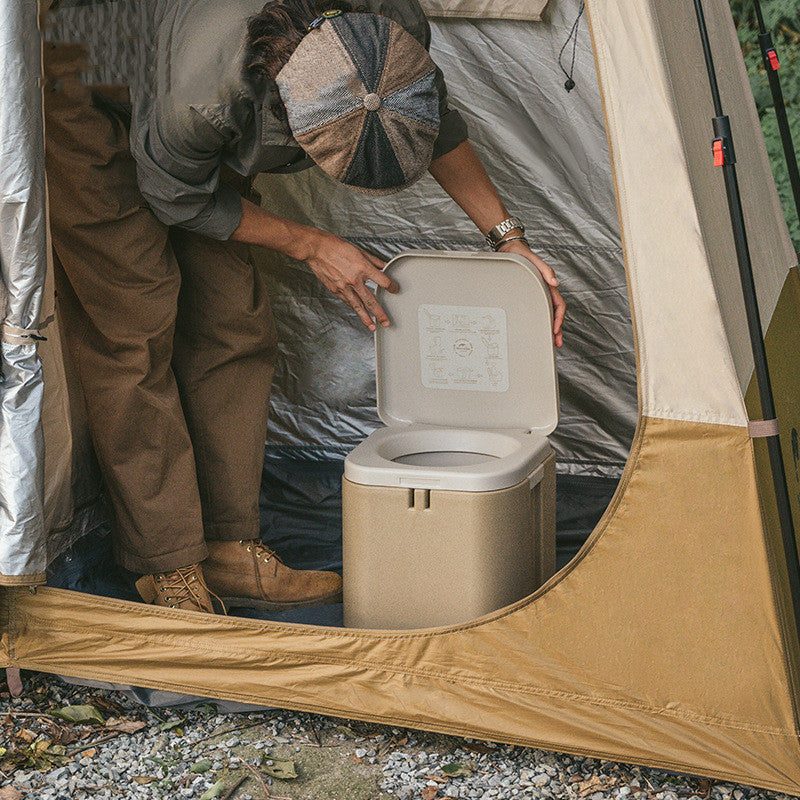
{"left": 6, "top": 420, "right": 800, "bottom": 794}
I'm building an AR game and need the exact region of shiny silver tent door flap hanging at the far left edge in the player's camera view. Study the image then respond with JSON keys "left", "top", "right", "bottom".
{"left": 0, "top": 0, "right": 47, "bottom": 584}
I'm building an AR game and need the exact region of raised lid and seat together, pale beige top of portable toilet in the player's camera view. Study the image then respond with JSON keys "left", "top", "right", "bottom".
{"left": 344, "top": 251, "right": 558, "bottom": 492}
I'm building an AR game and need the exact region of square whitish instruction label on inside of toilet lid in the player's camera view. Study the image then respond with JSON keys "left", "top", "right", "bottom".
{"left": 419, "top": 305, "right": 509, "bottom": 392}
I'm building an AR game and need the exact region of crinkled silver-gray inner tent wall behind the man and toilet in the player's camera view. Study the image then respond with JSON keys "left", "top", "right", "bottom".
{"left": 47, "top": 0, "right": 637, "bottom": 477}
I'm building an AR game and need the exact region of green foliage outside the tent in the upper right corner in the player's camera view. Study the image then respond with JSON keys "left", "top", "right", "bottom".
{"left": 731, "top": 0, "right": 800, "bottom": 251}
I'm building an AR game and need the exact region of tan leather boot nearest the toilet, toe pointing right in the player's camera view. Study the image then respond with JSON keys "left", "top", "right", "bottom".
{"left": 203, "top": 539, "right": 342, "bottom": 611}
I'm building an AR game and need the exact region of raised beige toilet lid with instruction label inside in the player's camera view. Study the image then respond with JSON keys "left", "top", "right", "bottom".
{"left": 375, "top": 250, "right": 558, "bottom": 436}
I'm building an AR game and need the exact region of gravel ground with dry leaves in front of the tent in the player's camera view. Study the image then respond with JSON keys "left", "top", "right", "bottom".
{"left": 0, "top": 673, "right": 800, "bottom": 800}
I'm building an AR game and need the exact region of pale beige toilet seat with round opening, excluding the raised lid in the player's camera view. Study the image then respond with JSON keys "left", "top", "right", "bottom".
{"left": 344, "top": 424, "right": 553, "bottom": 492}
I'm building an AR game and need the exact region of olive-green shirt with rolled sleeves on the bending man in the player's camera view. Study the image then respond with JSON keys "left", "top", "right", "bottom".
{"left": 131, "top": 0, "right": 467, "bottom": 239}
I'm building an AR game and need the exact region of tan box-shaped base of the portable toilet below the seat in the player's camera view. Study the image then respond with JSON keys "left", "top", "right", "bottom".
{"left": 342, "top": 454, "right": 556, "bottom": 630}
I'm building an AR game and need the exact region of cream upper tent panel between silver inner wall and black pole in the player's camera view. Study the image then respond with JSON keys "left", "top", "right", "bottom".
{"left": 587, "top": 0, "right": 747, "bottom": 432}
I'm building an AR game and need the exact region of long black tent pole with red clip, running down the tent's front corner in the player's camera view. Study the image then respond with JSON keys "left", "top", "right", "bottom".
{"left": 694, "top": 0, "right": 800, "bottom": 638}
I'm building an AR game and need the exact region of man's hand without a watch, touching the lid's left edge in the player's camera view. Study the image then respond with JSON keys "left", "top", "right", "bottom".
{"left": 303, "top": 231, "right": 400, "bottom": 331}
